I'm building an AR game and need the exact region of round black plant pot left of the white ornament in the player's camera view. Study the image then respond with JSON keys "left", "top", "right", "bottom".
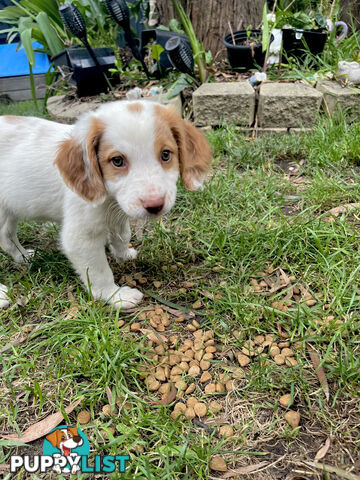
{"left": 223, "top": 30, "right": 265, "bottom": 71}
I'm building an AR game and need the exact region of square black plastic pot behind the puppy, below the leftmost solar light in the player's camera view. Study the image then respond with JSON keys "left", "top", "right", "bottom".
{"left": 51, "top": 47, "right": 116, "bottom": 97}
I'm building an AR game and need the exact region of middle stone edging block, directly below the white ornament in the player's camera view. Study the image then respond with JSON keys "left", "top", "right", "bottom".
{"left": 258, "top": 82, "right": 322, "bottom": 128}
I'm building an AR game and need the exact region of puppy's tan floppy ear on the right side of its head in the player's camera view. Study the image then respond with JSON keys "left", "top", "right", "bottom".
{"left": 179, "top": 120, "right": 211, "bottom": 190}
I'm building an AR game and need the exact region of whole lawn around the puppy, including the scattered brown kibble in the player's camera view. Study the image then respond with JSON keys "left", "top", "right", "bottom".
{"left": 0, "top": 99, "right": 360, "bottom": 480}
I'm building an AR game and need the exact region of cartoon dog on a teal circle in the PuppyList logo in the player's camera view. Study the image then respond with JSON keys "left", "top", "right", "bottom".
{"left": 43, "top": 425, "right": 90, "bottom": 475}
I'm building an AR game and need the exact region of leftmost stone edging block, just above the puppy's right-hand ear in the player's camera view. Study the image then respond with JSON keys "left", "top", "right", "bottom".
{"left": 193, "top": 82, "right": 255, "bottom": 127}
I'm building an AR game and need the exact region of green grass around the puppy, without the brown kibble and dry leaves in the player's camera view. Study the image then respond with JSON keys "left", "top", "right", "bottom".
{"left": 0, "top": 104, "right": 360, "bottom": 480}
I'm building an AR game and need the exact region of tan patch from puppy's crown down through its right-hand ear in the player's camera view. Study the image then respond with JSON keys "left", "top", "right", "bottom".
{"left": 155, "top": 105, "right": 211, "bottom": 190}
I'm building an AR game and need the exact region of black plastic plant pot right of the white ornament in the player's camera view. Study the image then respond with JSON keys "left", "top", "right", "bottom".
{"left": 282, "top": 28, "right": 327, "bottom": 61}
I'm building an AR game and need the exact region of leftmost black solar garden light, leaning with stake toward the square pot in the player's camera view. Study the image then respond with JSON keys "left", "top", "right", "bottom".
{"left": 59, "top": 2, "right": 113, "bottom": 90}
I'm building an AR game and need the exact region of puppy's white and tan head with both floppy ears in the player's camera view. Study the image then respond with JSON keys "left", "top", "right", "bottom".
{"left": 55, "top": 101, "right": 211, "bottom": 218}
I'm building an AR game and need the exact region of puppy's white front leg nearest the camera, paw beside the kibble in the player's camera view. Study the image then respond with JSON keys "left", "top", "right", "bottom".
{"left": 61, "top": 222, "right": 143, "bottom": 309}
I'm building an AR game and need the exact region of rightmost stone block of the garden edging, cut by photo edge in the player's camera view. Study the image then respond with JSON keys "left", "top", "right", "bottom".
{"left": 316, "top": 80, "right": 360, "bottom": 120}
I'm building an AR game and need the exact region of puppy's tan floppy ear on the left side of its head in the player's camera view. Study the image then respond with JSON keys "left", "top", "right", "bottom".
{"left": 55, "top": 117, "right": 106, "bottom": 202}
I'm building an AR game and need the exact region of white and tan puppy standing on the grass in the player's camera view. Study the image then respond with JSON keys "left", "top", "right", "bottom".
{"left": 0, "top": 101, "right": 211, "bottom": 308}
